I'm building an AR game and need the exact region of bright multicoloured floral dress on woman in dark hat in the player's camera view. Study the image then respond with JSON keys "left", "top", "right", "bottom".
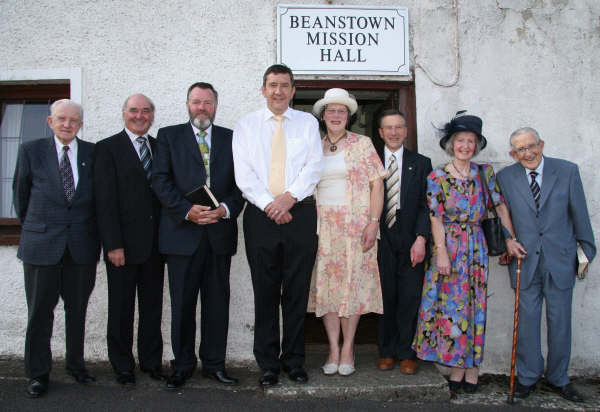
{"left": 413, "top": 163, "right": 504, "bottom": 368}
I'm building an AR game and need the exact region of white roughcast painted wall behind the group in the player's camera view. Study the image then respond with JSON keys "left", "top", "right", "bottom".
{"left": 0, "top": 0, "right": 600, "bottom": 375}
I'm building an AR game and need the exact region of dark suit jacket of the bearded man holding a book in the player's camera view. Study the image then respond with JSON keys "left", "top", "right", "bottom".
{"left": 152, "top": 122, "right": 244, "bottom": 256}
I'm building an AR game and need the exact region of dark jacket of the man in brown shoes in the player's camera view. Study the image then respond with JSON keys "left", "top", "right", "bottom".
{"left": 377, "top": 147, "right": 432, "bottom": 256}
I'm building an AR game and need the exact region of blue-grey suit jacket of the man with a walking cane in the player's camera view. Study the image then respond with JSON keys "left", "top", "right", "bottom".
{"left": 498, "top": 157, "right": 596, "bottom": 289}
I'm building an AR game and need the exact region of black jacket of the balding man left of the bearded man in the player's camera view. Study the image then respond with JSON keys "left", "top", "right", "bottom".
{"left": 94, "top": 130, "right": 160, "bottom": 264}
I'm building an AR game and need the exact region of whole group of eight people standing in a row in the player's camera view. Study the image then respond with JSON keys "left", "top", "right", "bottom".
{"left": 13, "top": 64, "right": 596, "bottom": 401}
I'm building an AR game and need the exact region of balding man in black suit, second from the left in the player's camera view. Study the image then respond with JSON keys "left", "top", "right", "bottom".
{"left": 94, "top": 94, "right": 164, "bottom": 385}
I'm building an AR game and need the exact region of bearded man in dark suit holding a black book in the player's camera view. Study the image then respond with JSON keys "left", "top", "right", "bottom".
{"left": 152, "top": 83, "right": 244, "bottom": 389}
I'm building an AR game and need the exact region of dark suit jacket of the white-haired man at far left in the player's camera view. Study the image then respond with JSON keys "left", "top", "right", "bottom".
{"left": 13, "top": 137, "right": 100, "bottom": 265}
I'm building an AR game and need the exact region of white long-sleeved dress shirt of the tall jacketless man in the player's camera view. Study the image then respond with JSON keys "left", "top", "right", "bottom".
{"left": 232, "top": 107, "right": 323, "bottom": 210}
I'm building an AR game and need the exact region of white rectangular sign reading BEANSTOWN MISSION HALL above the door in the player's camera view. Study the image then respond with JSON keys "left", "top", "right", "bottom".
{"left": 277, "top": 4, "right": 410, "bottom": 76}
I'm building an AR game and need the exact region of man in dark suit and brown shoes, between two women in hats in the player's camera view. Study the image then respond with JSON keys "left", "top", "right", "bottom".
{"left": 377, "top": 109, "right": 431, "bottom": 375}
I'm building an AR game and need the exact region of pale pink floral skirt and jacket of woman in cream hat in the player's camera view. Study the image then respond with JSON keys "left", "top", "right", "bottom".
{"left": 308, "top": 132, "right": 385, "bottom": 317}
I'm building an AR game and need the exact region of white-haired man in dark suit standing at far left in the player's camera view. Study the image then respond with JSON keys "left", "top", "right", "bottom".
{"left": 13, "top": 99, "right": 100, "bottom": 398}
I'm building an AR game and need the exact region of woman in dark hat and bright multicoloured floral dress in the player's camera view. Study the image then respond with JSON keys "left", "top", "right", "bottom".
{"left": 413, "top": 112, "right": 522, "bottom": 393}
